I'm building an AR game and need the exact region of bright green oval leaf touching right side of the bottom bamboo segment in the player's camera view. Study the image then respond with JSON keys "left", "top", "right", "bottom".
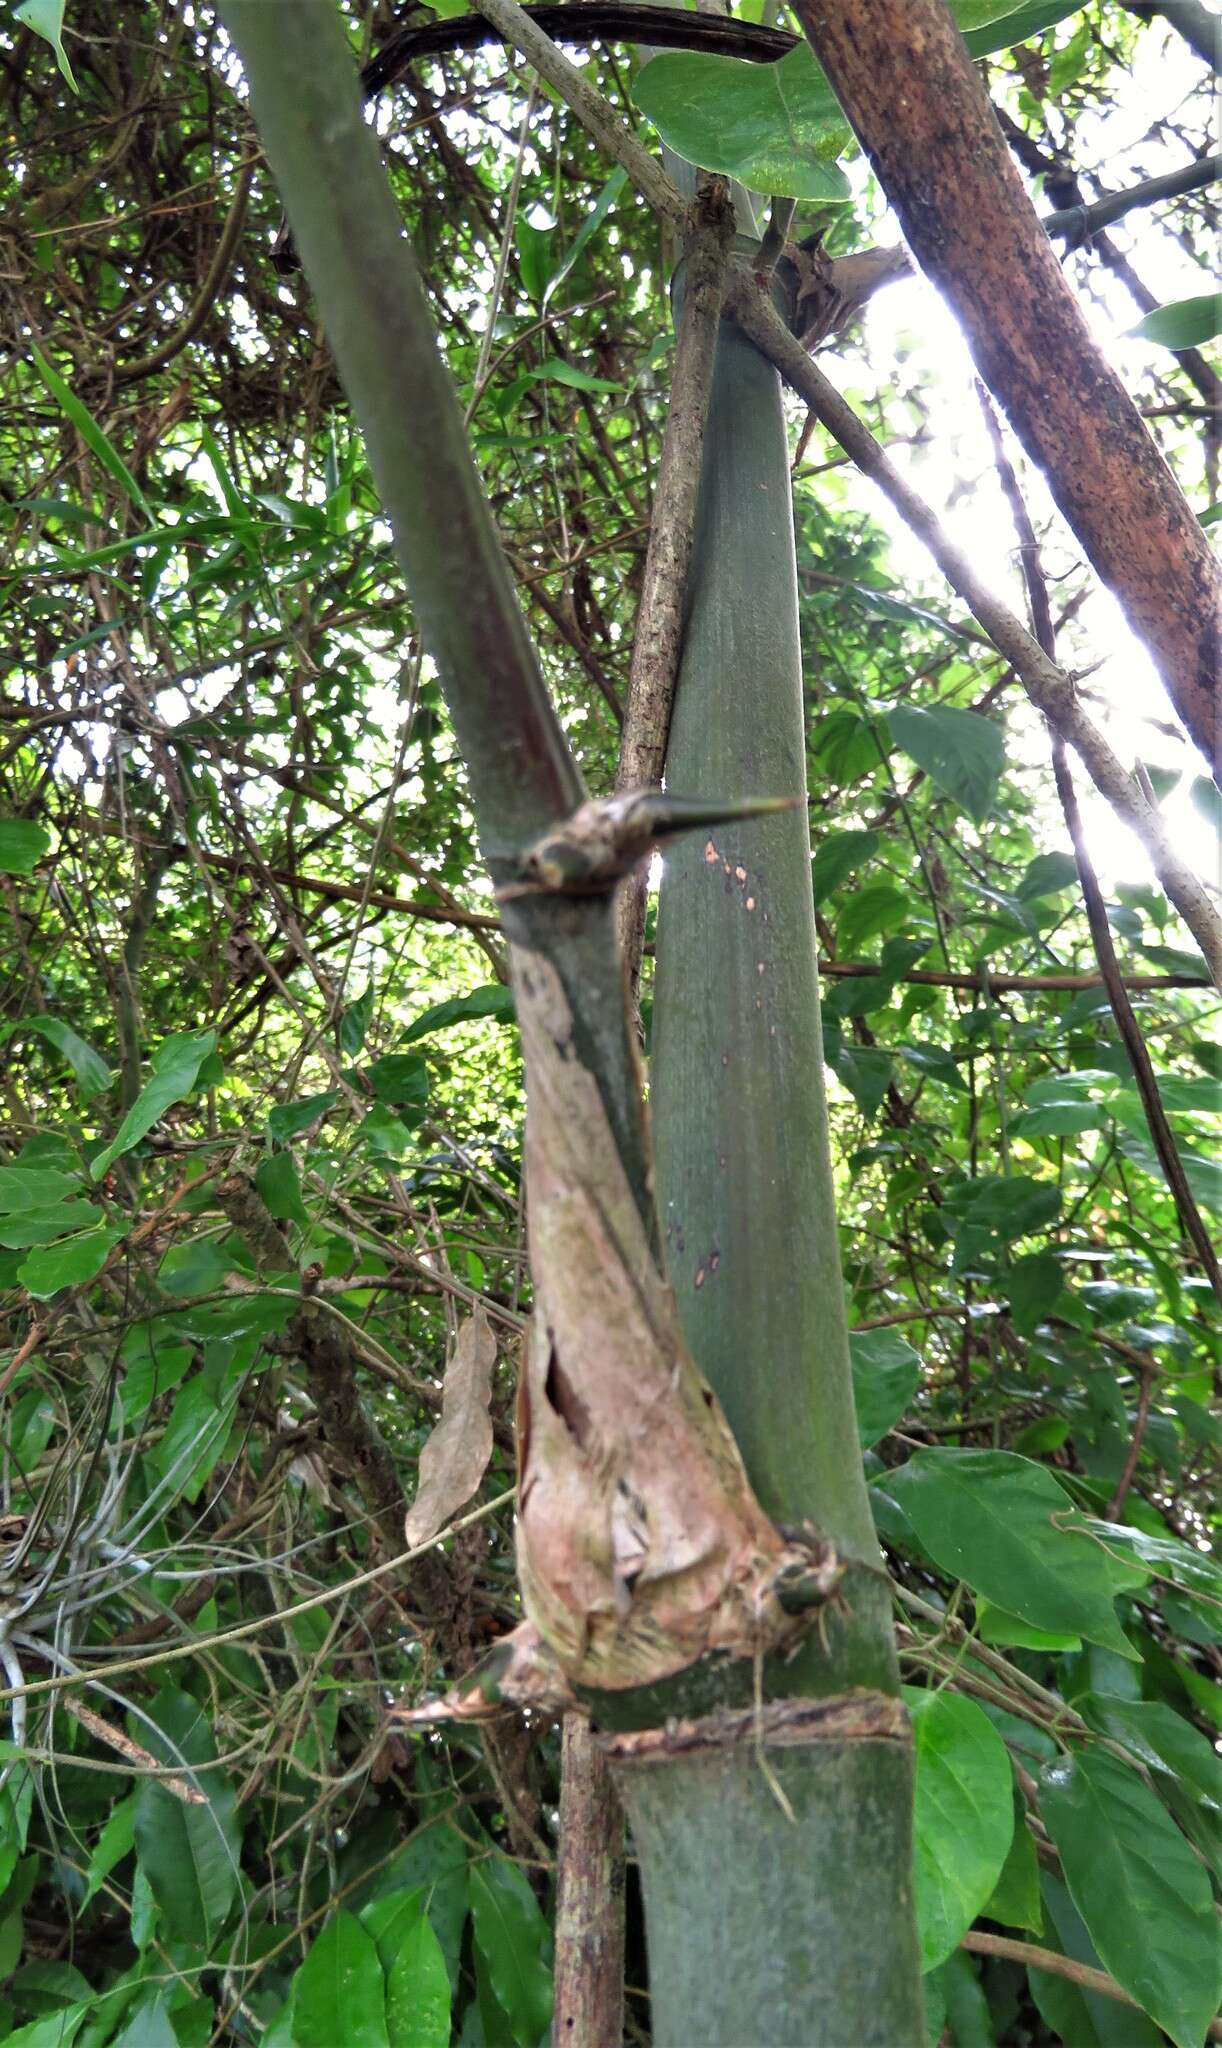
{"left": 905, "top": 1686, "right": 1013, "bottom": 1970}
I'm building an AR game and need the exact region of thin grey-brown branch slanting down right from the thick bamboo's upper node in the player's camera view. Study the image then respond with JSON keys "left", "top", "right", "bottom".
{"left": 729, "top": 270, "right": 1222, "bottom": 989}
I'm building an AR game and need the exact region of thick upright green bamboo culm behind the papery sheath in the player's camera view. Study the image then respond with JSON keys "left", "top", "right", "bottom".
{"left": 634, "top": 232, "right": 923, "bottom": 2048}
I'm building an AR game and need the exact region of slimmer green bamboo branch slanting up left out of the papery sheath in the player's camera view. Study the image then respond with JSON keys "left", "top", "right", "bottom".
{"left": 221, "top": 0, "right": 653, "bottom": 1223}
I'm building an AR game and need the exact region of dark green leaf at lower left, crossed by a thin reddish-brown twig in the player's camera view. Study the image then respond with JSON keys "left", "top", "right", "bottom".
{"left": 135, "top": 1692, "right": 242, "bottom": 1950}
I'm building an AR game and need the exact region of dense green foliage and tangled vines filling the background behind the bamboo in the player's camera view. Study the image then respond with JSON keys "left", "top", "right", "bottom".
{"left": 0, "top": 0, "right": 1222, "bottom": 2048}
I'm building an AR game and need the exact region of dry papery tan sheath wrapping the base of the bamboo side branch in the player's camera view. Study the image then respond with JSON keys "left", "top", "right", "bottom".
{"left": 512, "top": 948, "right": 800, "bottom": 1692}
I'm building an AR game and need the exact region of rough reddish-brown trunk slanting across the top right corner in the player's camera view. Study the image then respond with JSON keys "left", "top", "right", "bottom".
{"left": 794, "top": 0, "right": 1222, "bottom": 764}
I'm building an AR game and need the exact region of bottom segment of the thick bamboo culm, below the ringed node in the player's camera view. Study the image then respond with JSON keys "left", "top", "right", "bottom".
{"left": 616, "top": 1712, "right": 925, "bottom": 2048}
